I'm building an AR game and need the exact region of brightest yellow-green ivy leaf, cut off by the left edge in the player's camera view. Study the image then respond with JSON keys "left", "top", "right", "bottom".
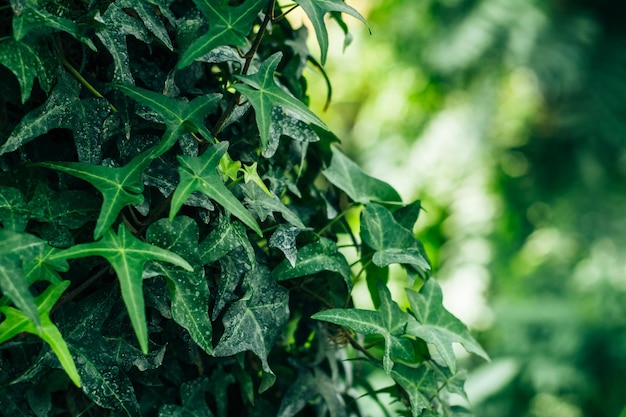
{"left": 0, "top": 281, "right": 81, "bottom": 387}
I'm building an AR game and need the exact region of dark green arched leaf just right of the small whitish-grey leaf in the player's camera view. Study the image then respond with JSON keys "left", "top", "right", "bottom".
{"left": 272, "top": 237, "right": 352, "bottom": 290}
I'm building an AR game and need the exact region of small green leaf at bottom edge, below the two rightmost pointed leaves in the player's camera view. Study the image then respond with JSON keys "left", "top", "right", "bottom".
{"left": 391, "top": 363, "right": 438, "bottom": 417}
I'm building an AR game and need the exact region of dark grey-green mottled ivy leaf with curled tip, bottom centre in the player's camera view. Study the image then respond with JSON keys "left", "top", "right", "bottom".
{"left": 214, "top": 267, "right": 289, "bottom": 392}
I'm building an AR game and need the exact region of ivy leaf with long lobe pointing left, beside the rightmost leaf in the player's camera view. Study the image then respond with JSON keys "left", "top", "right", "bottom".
{"left": 311, "top": 282, "right": 413, "bottom": 375}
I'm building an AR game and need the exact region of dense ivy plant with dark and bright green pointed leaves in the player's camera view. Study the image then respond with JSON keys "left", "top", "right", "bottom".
{"left": 0, "top": 0, "right": 486, "bottom": 417}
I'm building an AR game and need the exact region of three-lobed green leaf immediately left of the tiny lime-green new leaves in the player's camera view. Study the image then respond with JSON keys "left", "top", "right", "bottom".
{"left": 170, "top": 142, "right": 263, "bottom": 236}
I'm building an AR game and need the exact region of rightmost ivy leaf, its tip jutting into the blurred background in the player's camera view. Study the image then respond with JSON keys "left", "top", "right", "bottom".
{"left": 406, "top": 279, "right": 489, "bottom": 373}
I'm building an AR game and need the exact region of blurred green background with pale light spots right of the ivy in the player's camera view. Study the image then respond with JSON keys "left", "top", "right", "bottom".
{"left": 292, "top": 0, "right": 626, "bottom": 417}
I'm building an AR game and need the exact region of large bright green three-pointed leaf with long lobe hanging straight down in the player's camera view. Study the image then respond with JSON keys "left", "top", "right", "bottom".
{"left": 51, "top": 224, "right": 193, "bottom": 354}
